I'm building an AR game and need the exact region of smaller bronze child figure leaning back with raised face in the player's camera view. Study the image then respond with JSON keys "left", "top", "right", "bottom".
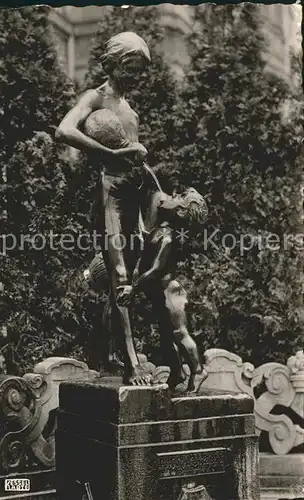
{"left": 119, "top": 188, "right": 208, "bottom": 391}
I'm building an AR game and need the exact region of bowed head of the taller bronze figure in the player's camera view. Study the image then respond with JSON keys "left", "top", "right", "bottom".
{"left": 101, "top": 31, "right": 151, "bottom": 88}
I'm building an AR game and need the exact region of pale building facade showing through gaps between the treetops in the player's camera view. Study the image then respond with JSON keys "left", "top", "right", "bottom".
{"left": 50, "top": 3, "right": 302, "bottom": 84}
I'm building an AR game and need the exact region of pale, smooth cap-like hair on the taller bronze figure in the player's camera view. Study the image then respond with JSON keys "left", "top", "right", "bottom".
{"left": 101, "top": 31, "right": 151, "bottom": 74}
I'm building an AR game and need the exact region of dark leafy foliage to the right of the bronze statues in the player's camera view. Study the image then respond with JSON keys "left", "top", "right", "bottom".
{"left": 166, "top": 4, "right": 303, "bottom": 363}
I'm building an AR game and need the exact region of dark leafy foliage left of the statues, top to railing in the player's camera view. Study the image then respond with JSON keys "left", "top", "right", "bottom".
{"left": 0, "top": 7, "right": 93, "bottom": 373}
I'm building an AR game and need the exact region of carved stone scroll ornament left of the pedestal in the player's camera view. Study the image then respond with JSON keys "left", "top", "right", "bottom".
{"left": 0, "top": 358, "right": 97, "bottom": 474}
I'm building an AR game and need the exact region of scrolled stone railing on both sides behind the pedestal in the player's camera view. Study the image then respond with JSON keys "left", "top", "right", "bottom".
{"left": 0, "top": 349, "right": 304, "bottom": 474}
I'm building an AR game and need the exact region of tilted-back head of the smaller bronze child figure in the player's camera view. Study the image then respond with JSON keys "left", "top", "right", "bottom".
{"left": 160, "top": 188, "right": 208, "bottom": 227}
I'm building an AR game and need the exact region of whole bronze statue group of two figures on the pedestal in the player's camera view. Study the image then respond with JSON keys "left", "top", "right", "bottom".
{"left": 56, "top": 32, "right": 207, "bottom": 390}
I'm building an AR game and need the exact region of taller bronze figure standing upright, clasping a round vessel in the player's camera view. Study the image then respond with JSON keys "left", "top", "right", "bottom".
{"left": 56, "top": 32, "right": 157, "bottom": 385}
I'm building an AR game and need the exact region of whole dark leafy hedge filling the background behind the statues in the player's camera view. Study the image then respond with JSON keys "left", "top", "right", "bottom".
{"left": 0, "top": 4, "right": 303, "bottom": 373}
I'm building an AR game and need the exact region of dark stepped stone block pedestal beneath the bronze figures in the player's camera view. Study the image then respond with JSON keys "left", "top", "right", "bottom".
{"left": 56, "top": 378, "right": 260, "bottom": 500}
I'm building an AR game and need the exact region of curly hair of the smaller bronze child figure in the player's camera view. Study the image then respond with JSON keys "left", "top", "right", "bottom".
{"left": 177, "top": 188, "right": 208, "bottom": 224}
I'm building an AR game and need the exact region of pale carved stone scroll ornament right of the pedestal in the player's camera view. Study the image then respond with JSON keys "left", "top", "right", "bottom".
{"left": 204, "top": 349, "right": 304, "bottom": 455}
